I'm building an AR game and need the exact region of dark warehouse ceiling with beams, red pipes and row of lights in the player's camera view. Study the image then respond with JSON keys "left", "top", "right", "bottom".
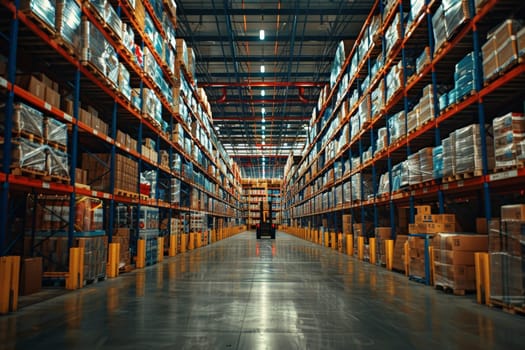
{"left": 177, "top": 0, "right": 374, "bottom": 178}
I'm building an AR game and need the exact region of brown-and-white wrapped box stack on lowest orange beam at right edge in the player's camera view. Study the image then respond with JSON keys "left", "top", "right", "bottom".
{"left": 492, "top": 113, "right": 525, "bottom": 168}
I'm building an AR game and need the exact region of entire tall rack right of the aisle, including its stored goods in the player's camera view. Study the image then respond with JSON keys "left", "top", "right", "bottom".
{"left": 282, "top": 0, "right": 525, "bottom": 300}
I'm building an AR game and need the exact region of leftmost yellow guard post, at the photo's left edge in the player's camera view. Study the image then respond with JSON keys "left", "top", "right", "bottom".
{"left": 0, "top": 256, "right": 20, "bottom": 314}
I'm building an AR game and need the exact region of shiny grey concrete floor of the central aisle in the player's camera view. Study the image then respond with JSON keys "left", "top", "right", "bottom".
{"left": 0, "top": 232, "right": 525, "bottom": 350}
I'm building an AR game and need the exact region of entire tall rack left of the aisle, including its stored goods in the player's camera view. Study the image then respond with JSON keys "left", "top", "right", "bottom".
{"left": 0, "top": 0, "right": 241, "bottom": 284}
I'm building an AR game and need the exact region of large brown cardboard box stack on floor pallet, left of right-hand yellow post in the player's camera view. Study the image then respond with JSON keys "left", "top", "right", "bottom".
{"left": 432, "top": 233, "right": 488, "bottom": 291}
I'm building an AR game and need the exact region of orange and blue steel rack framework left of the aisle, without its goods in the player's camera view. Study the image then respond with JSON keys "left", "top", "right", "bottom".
{"left": 0, "top": 0, "right": 241, "bottom": 274}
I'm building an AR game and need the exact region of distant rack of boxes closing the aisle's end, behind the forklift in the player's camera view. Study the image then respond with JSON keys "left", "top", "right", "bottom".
{"left": 241, "top": 179, "right": 281, "bottom": 229}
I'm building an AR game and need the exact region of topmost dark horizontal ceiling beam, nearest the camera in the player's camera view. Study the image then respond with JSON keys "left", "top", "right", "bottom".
{"left": 183, "top": 6, "right": 370, "bottom": 16}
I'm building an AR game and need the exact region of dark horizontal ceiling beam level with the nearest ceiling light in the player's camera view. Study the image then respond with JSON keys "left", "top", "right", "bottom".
{"left": 180, "top": 34, "right": 356, "bottom": 44}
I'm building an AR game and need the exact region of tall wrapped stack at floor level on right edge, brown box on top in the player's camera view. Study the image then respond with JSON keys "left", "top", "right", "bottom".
{"left": 489, "top": 204, "right": 525, "bottom": 307}
